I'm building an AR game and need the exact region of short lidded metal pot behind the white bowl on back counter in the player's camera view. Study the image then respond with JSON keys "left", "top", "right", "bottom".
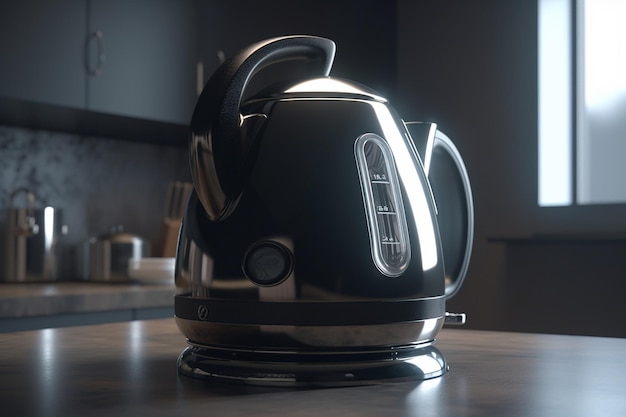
{"left": 83, "top": 228, "right": 151, "bottom": 282}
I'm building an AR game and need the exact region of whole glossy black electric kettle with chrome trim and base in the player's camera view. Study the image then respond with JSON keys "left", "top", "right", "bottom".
{"left": 175, "top": 36, "right": 473, "bottom": 385}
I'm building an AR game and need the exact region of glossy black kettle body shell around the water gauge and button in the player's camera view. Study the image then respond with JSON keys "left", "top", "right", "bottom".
{"left": 177, "top": 96, "right": 445, "bottom": 302}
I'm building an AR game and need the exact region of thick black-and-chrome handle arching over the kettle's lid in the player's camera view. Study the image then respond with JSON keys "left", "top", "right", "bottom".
{"left": 189, "top": 35, "right": 335, "bottom": 220}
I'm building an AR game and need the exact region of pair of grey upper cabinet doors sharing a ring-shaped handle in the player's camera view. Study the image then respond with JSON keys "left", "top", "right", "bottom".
{"left": 0, "top": 0, "right": 202, "bottom": 125}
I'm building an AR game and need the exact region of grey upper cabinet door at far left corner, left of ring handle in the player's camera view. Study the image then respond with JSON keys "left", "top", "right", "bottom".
{"left": 0, "top": 0, "right": 86, "bottom": 108}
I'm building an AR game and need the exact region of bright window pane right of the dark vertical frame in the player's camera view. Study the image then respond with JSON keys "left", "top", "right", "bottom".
{"left": 577, "top": 0, "right": 626, "bottom": 204}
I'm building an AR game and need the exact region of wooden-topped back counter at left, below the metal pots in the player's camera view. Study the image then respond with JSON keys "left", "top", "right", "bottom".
{"left": 0, "top": 282, "right": 174, "bottom": 332}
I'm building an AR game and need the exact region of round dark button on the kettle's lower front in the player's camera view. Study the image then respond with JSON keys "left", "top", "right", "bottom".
{"left": 243, "top": 241, "right": 293, "bottom": 286}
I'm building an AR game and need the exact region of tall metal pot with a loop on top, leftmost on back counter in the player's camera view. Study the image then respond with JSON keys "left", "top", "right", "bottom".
{"left": 2, "top": 188, "right": 68, "bottom": 282}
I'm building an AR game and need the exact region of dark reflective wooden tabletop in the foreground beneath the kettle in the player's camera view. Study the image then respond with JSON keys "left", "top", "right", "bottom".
{"left": 0, "top": 319, "right": 626, "bottom": 417}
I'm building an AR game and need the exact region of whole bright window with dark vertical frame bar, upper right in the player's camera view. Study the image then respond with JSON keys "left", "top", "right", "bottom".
{"left": 538, "top": 0, "right": 626, "bottom": 206}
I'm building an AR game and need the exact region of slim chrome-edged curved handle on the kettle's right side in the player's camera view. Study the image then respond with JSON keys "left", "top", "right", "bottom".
{"left": 433, "top": 130, "right": 474, "bottom": 298}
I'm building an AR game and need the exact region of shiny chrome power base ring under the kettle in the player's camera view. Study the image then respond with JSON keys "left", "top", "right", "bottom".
{"left": 178, "top": 344, "right": 448, "bottom": 387}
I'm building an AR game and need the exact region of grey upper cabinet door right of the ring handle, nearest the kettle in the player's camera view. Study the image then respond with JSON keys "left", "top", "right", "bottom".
{"left": 87, "top": 0, "right": 197, "bottom": 124}
